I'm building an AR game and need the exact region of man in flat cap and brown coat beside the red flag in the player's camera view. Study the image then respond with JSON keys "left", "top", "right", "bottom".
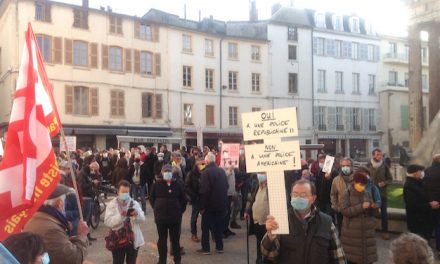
{"left": 23, "top": 184, "right": 89, "bottom": 264}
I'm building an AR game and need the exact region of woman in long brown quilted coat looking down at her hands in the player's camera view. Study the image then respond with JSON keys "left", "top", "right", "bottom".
{"left": 341, "top": 172, "right": 377, "bottom": 264}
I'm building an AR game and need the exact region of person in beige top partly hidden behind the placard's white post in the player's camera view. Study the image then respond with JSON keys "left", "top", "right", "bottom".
{"left": 244, "top": 172, "right": 269, "bottom": 264}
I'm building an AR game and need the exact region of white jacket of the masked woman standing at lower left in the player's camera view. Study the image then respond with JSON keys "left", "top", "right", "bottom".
{"left": 104, "top": 197, "right": 145, "bottom": 249}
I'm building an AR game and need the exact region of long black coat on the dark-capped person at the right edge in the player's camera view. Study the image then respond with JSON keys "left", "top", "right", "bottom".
{"left": 403, "top": 177, "right": 434, "bottom": 238}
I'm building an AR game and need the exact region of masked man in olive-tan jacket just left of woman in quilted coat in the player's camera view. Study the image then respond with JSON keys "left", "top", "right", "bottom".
{"left": 330, "top": 158, "right": 353, "bottom": 234}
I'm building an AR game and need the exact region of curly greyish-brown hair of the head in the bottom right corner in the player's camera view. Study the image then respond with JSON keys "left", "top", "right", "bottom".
{"left": 390, "top": 233, "right": 435, "bottom": 264}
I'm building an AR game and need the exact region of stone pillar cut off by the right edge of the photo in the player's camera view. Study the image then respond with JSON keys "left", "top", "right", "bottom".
{"left": 425, "top": 23, "right": 440, "bottom": 125}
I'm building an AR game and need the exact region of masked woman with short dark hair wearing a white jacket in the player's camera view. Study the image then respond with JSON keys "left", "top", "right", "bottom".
{"left": 104, "top": 180, "right": 145, "bottom": 264}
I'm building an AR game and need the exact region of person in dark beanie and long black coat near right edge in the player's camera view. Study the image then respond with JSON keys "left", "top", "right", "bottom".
{"left": 403, "top": 164, "right": 439, "bottom": 241}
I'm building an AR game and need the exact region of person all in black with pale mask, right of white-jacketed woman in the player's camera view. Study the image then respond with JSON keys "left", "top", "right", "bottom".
{"left": 150, "top": 164, "right": 186, "bottom": 264}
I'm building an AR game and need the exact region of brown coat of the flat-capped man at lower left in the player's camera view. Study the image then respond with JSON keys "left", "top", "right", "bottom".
{"left": 23, "top": 209, "right": 88, "bottom": 264}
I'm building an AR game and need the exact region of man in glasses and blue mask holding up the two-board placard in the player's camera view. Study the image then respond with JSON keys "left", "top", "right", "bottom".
{"left": 261, "top": 180, "right": 346, "bottom": 264}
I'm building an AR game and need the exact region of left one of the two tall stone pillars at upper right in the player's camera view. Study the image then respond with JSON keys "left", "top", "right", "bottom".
{"left": 408, "top": 26, "right": 423, "bottom": 150}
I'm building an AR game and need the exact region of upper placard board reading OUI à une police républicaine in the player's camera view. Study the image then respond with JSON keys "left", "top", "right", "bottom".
{"left": 242, "top": 107, "right": 298, "bottom": 140}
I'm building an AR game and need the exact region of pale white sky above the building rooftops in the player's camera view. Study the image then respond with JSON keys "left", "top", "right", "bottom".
{"left": 55, "top": 0, "right": 408, "bottom": 36}
